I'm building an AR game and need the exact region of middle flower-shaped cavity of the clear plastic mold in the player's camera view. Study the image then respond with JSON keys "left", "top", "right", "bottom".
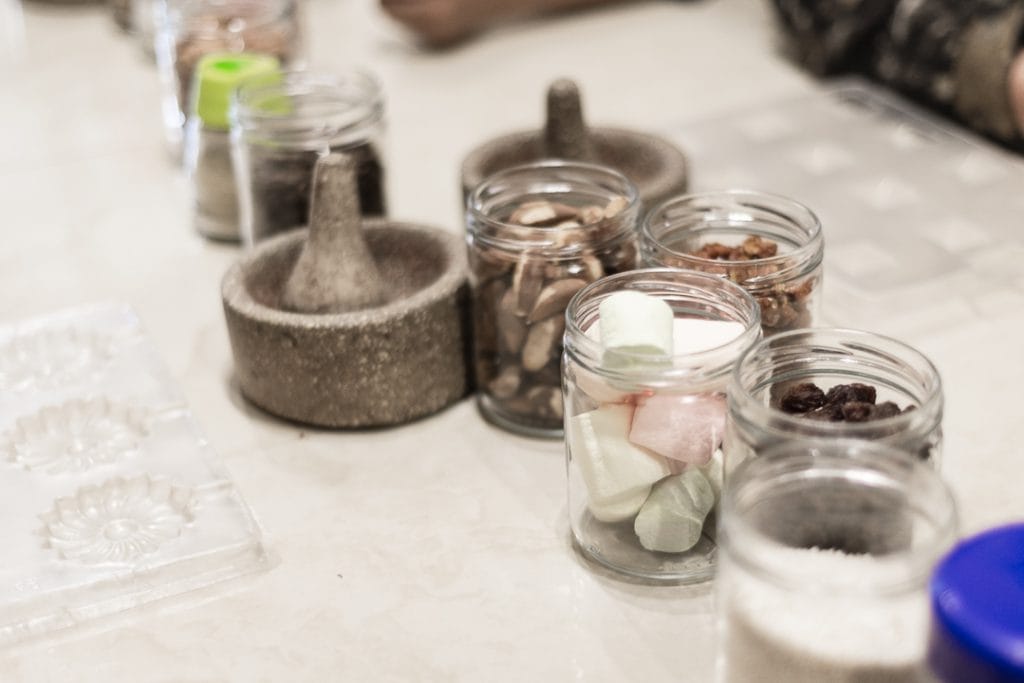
{"left": 0, "top": 398, "right": 150, "bottom": 474}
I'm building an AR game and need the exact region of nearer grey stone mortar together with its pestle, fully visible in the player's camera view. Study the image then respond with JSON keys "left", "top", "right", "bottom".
{"left": 221, "top": 154, "right": 469, "bottom": 427}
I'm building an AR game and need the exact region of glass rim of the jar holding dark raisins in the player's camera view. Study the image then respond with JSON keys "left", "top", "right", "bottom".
{"left": 729, "top": 328, "right": 943, "bottom": 437}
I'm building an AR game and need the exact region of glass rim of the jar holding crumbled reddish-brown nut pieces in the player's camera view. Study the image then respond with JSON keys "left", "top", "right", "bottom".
{"left": 640, "top": 188, "right": 824, "bottom": 287}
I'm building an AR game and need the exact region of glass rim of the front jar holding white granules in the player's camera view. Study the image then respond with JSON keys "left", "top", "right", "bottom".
{"left": 720, "top": 438, "right": 959, "bottom": 593}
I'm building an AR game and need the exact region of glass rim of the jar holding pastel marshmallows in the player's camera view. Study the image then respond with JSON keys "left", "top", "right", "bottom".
{"left": 563, "top": 268, "right": 761, "bottom": 383}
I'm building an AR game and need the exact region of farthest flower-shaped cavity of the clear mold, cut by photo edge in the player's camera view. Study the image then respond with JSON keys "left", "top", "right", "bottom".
{"left": 0, "top": 329, "right": 114, "bottom": 391}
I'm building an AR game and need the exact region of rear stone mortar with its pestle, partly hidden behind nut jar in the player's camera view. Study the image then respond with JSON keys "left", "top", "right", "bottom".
{"left": 462, "top": 79, "right": 688, "bottom": 207}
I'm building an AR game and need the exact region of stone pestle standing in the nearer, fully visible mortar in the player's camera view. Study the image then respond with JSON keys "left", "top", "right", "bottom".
{"left": 281, "top": 153, "right": 387, "bottom": 313}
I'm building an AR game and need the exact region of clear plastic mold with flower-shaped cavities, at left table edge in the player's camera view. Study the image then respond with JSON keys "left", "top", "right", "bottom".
{"left": 0, "top": 304, "right": 266, "bottom": 645}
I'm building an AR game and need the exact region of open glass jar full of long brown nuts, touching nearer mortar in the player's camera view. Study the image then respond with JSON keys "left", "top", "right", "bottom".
{"left": 466, "top": 161, "right": 640, "bottom": 437}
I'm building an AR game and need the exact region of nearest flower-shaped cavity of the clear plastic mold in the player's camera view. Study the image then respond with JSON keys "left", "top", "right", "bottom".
{"left": 42, "top": 475, "right": 195, "bottom": 564}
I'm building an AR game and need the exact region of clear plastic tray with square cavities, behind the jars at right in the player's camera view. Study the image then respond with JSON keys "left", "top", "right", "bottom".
{"left": 669, "top": 79, "right": 1024, "bottom": 336}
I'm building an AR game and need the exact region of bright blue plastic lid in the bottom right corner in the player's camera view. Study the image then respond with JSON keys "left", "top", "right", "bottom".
{"left": 928, "top": 523, "right": 1024, "bottom": 683}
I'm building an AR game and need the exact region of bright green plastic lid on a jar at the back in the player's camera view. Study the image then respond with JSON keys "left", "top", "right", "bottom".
{"left": 196, "top": 52, "right": 281, "bottom": 130}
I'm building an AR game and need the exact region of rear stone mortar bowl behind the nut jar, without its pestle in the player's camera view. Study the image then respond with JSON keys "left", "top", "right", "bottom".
{"left": 462, "top": 128, "right": 689, "bottom": 208}
